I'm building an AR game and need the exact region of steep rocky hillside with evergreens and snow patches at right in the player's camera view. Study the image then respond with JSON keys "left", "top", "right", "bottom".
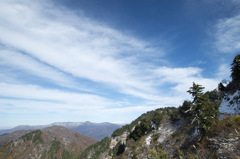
{"left": 80, "top": 55, "right": 240, "bottom": 159}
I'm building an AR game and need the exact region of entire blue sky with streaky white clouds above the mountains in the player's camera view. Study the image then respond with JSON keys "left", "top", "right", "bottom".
{"left": 0, "top": 0, "right": 240, "bottom": 128}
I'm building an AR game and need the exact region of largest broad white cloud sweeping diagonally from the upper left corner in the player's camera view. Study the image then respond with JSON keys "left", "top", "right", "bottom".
{"left": 0, "top": 1, "right": 162, "bottom": 99}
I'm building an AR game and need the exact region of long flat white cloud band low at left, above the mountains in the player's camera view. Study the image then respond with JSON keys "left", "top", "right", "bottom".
{"left": 0, "top": 83, "right": 110, "bottom": 108}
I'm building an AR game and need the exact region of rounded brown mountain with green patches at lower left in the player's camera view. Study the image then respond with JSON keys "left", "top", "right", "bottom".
{"left": 0, "top": 126, "right": 97, "bottom": 159}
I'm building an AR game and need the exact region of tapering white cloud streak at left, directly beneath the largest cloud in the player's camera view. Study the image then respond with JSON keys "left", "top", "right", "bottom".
{"left": 0, "top": 49, "right": 91, "bottom": 91}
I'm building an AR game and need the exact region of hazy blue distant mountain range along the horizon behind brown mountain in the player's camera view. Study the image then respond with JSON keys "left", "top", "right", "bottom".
{"left": 0, "top": 121, "right": 122, "bottom": 141}
